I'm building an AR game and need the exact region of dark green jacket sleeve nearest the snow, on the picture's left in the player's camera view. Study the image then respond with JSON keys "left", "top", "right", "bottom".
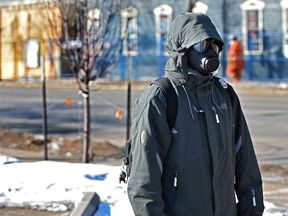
{"left": 127, "top": 87, "right": 171, "bottom": 216}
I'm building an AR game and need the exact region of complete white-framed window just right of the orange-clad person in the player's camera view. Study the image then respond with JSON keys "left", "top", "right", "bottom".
{"left": 241, "top": 0, "right": 265, "bottom": 55}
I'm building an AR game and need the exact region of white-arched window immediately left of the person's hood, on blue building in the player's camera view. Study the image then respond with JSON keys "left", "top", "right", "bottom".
{"left": 154, "top": 4, "right": 172, "bottom": 55}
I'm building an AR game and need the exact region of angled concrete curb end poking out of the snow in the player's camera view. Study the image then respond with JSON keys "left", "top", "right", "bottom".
{"left": 70, "top": 192, "right": 100, "bottom": 216}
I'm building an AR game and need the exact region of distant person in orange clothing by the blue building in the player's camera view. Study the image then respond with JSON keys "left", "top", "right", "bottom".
{"left": 227, "top": 35, "right": 244, "bottom": 82}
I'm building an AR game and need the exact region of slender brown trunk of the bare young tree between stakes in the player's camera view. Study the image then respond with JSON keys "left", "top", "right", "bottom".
{"left": 82, "top": 84, "right": 90, "bottom": 163}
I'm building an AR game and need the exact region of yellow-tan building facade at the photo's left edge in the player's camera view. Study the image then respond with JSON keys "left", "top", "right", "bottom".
{"left": 0, "top": 0, "right": 61, "bottom": 80}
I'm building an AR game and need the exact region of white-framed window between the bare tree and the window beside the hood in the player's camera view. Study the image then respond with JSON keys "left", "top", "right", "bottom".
{"left": 121, "top": 7, "right": 138, "bottom": 55}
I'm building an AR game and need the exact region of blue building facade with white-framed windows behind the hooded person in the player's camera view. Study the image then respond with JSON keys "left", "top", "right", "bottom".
{"left": 117, "top": 0, "right": 288, "bottom": 81}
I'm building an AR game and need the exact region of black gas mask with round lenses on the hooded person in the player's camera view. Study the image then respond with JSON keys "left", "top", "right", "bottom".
{"left": 186, "top": 39, "right": 220, "bottom": 75}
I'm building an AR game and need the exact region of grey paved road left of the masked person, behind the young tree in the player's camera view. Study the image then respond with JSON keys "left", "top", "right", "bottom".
{"left": 0, "top": 88, "right": 138, "bottom": 145}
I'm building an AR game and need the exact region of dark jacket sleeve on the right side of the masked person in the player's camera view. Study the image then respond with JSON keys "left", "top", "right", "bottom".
{"left": 233, "top": 88, "right": 264, "bottom": 216}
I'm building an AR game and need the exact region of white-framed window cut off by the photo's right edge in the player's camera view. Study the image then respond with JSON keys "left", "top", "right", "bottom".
{"left": 280, "top": 0, "right": 288, "bottom": 57}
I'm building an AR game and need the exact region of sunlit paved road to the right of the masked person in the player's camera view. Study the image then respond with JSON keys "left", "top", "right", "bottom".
{"left": 240, "top": 94, "right": 288, "bottom": 167}
